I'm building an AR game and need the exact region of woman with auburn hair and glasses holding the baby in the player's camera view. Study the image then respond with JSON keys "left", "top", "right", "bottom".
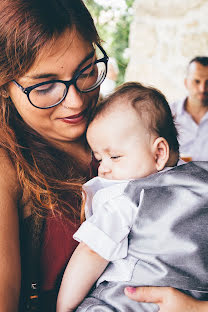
{"left": 0, "top": 0, "right": 207, "bottom": 312}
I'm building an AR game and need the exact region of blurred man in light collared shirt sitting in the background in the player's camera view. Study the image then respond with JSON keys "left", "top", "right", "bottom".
{"left": 170, "top": 56, "right": 208, "bottom": 161}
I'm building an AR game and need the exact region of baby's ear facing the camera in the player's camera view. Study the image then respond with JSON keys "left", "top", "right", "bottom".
{"left": 153, "top": 137, "right": 170, "bottom": 171}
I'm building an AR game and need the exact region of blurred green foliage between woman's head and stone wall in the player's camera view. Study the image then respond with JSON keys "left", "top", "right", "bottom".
{"left": 85, "top": 0, "right": 134, "bottom": 84}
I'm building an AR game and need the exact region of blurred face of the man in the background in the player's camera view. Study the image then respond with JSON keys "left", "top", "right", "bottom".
{"left": 185, "top": 62, "right": 208, "bottom": 106}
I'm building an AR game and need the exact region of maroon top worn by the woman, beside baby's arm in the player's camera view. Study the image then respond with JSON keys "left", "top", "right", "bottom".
{"left": 38, "top": 158, "right": 98, "bottom": 311}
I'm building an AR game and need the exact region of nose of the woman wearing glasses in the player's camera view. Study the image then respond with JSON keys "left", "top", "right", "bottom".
{"left": 62, "top": 85, "right": 84, "bottom": 108}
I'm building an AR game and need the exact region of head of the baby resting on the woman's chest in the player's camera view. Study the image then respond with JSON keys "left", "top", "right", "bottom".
{"left": 87, "top": 82, "right": 179, "bottom": 180}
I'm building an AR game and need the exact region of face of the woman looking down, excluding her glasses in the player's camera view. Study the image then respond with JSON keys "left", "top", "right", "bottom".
{"left": 9, "top": 31, "right": 99, "bottom": 145}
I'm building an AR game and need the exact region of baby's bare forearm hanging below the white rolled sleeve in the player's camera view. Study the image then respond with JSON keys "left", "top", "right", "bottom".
{"left": 57, "top": 242, "right": 109, "bottom": 312}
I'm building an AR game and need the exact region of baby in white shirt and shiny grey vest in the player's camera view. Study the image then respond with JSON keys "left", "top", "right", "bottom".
{"left": 57, "top": 82, "right": 208, "bottom": 312}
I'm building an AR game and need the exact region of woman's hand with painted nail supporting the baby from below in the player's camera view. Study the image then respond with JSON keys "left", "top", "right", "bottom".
{"left": 124, "top": 287, "right": 208, "bottom": 312}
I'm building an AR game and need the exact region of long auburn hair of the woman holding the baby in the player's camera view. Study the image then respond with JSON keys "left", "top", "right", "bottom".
{"left": 0, "top": 0, "right": 99, "bottom": 220}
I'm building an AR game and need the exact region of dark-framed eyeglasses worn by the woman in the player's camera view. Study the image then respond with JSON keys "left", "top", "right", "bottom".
{"left": 12, "top": 43, "right": 108, "bottom": 109}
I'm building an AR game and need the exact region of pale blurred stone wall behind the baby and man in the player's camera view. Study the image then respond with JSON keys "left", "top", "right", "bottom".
{"left": 125, "top": 0, "right": 208, "bottom": 101}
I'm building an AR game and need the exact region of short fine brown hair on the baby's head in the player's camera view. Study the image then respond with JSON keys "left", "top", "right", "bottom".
{"left": 90, "top": 82, "right": 179, "bottom": 153}
